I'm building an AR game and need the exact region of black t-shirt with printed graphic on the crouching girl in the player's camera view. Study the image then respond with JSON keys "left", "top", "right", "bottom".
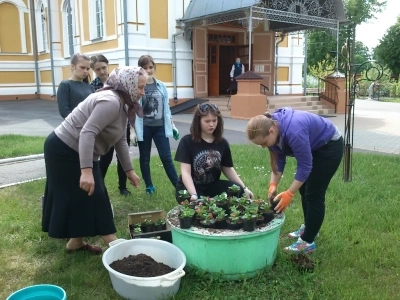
{"left": 175, "top": 135, "right": 233, "bottom": 185}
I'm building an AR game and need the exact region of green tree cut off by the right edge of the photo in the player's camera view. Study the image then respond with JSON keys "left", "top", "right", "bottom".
{"left": 374, "top": 16, "right": 400, "bottom": 79}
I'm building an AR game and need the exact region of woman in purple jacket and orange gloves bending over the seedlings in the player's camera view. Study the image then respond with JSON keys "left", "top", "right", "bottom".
{"left": 247, "top": 107, "right": 343, "bottom": 253}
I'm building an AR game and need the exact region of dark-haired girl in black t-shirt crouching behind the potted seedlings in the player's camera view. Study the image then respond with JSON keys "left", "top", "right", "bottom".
{"left": 175, "top": 103, "right": 253, "bottom": 202}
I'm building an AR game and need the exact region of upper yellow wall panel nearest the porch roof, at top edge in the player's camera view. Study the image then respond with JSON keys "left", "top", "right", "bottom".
{"left": 149, "top": 0, "right": 168, "bottom": 39}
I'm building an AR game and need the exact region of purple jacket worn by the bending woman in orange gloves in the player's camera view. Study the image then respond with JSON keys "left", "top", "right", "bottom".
{"left": 269, "top": 107, "right": 336, "bottom": 182}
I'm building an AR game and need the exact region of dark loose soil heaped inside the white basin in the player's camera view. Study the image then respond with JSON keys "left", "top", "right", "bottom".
{"left": 110, "top": 254, "right": 176, "bottom": 277}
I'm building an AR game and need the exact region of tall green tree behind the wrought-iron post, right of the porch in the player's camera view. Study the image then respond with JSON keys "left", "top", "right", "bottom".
{"left": 307, "top": 0, "right": 386, "bottom": 69}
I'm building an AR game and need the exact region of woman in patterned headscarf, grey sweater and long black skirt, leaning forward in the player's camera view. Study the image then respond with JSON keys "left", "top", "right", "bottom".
{"left": 42, "top": 67, "right": 147, "bottom": 254}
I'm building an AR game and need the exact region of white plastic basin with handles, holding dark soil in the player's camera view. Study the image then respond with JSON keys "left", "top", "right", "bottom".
{"left": 102, "top": 239, "right": 186, "bottom": 300}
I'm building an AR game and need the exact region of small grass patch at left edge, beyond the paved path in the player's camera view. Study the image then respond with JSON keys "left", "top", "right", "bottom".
{"left": 0, "top": 134, "right": 46, "bottom": 159}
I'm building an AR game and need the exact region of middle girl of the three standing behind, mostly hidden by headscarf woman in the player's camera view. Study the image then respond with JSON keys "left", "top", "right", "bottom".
{"left": 90, "top": 54, "right": 131, "bottom": 196}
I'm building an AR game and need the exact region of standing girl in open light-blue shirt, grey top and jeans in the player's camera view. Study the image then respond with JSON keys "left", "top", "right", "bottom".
{"left": 135, "top": 55, "right": 179, "bottom": 195}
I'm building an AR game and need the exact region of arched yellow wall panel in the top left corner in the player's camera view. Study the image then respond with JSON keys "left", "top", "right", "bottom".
{"left": 0, "top": 2, "right": 22, "bottom": 53}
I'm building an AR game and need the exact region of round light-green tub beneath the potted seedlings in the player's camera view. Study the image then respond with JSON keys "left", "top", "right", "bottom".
{"left": 167, "top": 208, "right": 285, "bottom": 280}
